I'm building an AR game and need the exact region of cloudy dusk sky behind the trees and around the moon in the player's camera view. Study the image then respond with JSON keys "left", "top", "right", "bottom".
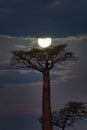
{"left": 0, "top": 0, "right": 87, "bottom": 130}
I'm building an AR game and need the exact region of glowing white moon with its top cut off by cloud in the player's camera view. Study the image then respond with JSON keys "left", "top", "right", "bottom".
{"left": 38, "top": 38, "right": 52, "bottom": 48}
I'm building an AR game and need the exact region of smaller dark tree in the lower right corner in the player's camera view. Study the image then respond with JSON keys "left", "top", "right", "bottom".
{"left": 52, "top": 102, "right": 87, "bottom": 130}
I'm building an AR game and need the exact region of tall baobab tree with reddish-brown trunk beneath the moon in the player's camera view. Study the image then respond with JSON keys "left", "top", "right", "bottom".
{"left": 11, "top": 44, "right": 75, "bottom": 130}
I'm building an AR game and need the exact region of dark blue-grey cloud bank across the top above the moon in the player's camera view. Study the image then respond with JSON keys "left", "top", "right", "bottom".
{"left": 0, "top": 0, "right": 87, "bottom": 36}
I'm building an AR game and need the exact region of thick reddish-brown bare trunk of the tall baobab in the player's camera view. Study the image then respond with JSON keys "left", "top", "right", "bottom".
{"left": 42, "top": 69, "right": 53, "bottom": 130}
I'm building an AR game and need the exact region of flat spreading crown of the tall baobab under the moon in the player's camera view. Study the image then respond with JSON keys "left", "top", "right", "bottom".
{"left": 11, "top": 44, "right": 75, "bottom": 72}
